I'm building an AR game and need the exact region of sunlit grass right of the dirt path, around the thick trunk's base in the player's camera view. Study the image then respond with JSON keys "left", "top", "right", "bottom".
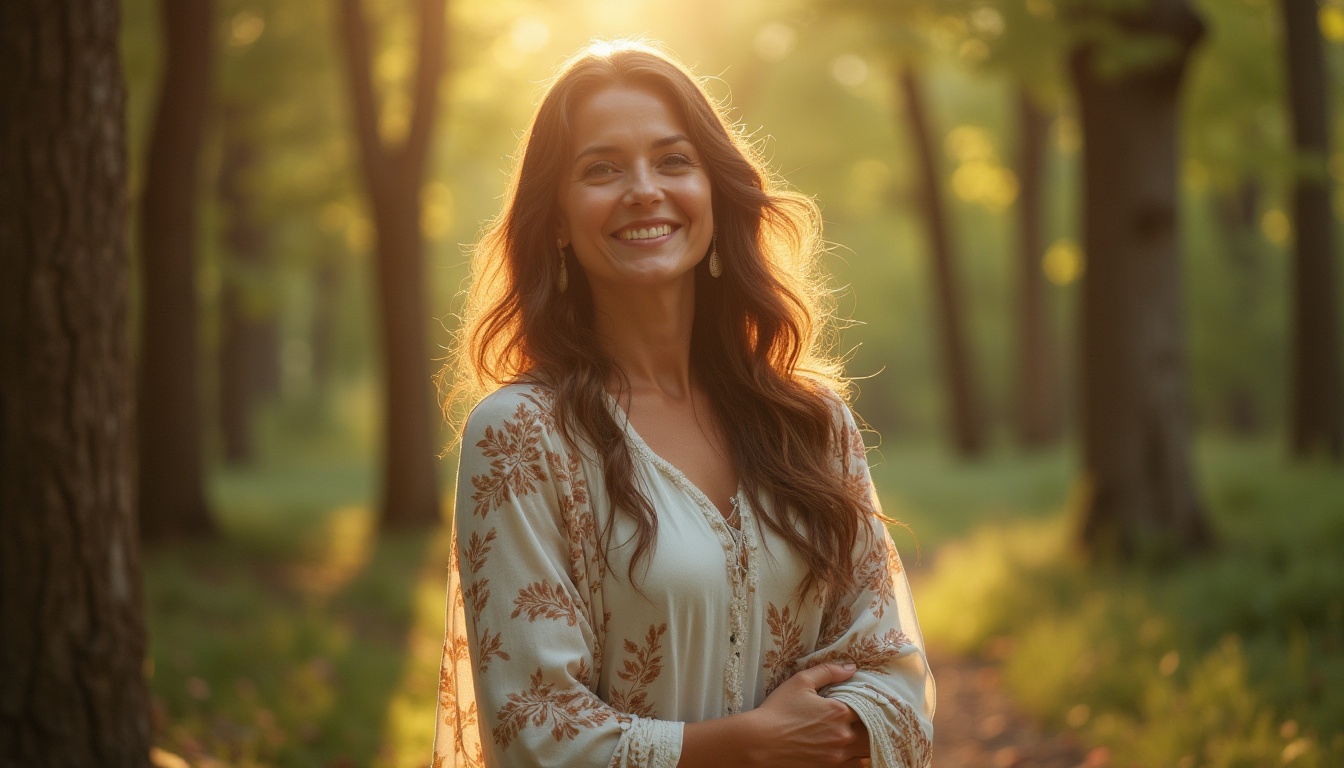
{"left": 917, "top": 444, "right": 1344, "bottom": 767}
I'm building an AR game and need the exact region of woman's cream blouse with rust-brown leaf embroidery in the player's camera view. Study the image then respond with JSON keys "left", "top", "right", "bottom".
{"left": 433, "top": 385, "right": 934, "bottom": 768}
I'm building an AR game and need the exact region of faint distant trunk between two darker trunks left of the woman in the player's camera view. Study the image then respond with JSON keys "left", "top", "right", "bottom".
{"left": 219, "top": 104, "right": 278, "bottom": 464}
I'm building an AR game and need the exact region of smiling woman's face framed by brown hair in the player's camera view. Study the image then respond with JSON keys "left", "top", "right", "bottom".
{"left": 558, "top": 85, "right": 714, "bottom": 293}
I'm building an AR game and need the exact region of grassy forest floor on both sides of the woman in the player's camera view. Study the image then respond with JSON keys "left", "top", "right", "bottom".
{"left": 145, "top": 443, "right": 1344, "bottom": 768}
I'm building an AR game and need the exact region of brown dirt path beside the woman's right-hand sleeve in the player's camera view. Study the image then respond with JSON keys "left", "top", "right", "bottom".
{"left": 929, "top": 648, "right": 1110, "bottom": 768}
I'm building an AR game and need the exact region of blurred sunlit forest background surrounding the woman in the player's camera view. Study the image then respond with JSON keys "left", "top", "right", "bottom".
{"left": 107, "top": 0, "right": 1344, "bottom": 768}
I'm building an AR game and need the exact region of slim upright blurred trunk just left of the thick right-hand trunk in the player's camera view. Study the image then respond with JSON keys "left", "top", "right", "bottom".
{"left": 1013, "top": 89, "right": 1060, "bottom": 448}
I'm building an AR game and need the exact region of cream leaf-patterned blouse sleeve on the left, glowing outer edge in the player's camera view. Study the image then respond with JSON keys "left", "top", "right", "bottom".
{"left": 433, "top": 387, "right": 681, "bottom": 768}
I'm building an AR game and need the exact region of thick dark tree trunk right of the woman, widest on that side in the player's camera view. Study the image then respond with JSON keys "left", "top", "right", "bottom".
{"left": 1071, "top": 0, "right": 1211, "bottom": 560}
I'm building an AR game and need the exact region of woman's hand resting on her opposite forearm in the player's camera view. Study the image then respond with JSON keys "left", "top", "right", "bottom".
{"left": 743, "top": 664, "right": 868, "bottom": 768}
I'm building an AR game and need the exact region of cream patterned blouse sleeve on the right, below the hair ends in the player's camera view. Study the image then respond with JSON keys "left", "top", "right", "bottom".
{"left": 798, "top": 402, "right": 934, "bottom": 768}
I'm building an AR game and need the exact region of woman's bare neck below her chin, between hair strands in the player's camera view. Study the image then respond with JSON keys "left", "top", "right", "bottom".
{"left": 593, "top": 278, "right": 695, "bottom": 399}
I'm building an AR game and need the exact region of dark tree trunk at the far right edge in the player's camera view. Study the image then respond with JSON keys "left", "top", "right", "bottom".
{"left": 1284, "top": 0, "right": 1344, "bottom": 463}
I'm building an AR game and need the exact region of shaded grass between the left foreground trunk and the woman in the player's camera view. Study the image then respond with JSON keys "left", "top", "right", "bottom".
{"left": 146, "top": 454, "right": 448, "bottom": 768}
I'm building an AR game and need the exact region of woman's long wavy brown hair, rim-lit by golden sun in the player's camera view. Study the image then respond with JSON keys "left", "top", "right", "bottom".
{"left": 439, "top": 42, "right": 874, "bottom": 592}
